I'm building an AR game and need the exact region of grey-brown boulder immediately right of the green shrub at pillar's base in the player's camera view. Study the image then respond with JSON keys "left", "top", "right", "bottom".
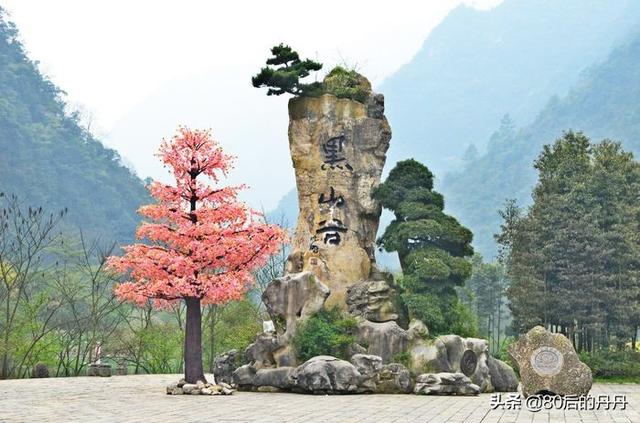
{"left": 356, "top": 320, "right": 409, "bottom": 363}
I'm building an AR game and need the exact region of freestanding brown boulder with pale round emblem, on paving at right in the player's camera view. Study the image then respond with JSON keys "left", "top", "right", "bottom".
{"left": 509, "top": 326, "right": 593, "bottom": 397}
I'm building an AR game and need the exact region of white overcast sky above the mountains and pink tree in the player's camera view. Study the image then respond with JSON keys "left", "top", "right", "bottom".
{"left": 0, "top": 0, "right": 501, "bottom": 210}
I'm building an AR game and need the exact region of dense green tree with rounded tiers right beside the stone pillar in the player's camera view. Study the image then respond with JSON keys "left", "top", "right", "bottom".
{"left": 373, "top": 160, "right": 473, "bottom": 335}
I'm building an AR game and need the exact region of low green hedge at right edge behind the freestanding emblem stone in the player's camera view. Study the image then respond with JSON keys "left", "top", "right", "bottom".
{"left": 580, "top": 350, "right": 640, "bottom": 380}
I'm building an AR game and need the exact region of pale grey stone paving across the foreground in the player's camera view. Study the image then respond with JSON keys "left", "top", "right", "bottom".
{"left": 0, "top": 375, "right": 640, "bottom": 423}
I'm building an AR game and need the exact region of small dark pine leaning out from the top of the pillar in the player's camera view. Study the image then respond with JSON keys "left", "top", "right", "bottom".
{"left": 251, "top": 44, "right": 322, "bottom": 96}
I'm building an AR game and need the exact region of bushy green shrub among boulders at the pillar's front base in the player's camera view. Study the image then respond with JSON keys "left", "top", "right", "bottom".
{"left": 293, "top": 307, "right": 358, "bottom": 361}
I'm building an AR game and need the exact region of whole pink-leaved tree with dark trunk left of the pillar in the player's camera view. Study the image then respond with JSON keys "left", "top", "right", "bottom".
{"left": 109, "top": 128, "right": 286, "bottom": 383}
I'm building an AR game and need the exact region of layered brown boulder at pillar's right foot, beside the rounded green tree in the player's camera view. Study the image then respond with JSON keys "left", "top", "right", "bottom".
{"left": 346, "top": 280, "right": 398, "bottom": 322}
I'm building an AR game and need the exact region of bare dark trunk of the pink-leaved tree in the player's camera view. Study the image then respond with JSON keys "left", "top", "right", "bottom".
{"left": 184, "top": 298, "right": 207, "bottom": 383}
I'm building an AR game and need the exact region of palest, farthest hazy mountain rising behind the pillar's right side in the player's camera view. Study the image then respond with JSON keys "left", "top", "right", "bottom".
{"left": 379, "top": 0, "right": 640, "bottom": 176}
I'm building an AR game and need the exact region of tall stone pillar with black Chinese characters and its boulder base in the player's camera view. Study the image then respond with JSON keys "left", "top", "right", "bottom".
{"left": 232, "top": 70, "right": 515, "bottom": 395}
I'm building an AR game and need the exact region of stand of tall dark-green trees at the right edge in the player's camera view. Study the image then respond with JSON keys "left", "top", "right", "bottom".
{"left": 496, "top": 132, "right": 640, "bottom": 351}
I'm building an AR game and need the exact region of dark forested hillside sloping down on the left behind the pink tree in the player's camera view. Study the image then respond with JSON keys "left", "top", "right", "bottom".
{"left": 0, "top": 9, "right": 149, "bottom": 241}
